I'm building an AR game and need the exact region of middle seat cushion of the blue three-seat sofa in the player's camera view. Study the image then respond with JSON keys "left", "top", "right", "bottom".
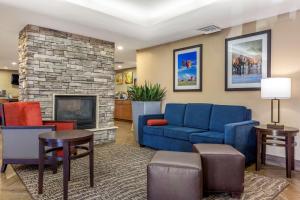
{"left": 164, "top": 126, "right": 206, "bottom": 141}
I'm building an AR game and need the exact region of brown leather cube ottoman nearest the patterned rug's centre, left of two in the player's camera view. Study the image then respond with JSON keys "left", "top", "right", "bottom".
{"left": 147, "top": 151, "right": 202, "bottom": 200}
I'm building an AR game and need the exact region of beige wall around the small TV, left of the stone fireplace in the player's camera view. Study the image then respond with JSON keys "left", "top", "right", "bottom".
{"left": 0, "top": 70, "right": 19, "bottom": 96}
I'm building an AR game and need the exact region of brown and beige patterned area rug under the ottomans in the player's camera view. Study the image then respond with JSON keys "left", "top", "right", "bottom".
{"left": 14, "top": 144, "right": 288, "bottom": 200}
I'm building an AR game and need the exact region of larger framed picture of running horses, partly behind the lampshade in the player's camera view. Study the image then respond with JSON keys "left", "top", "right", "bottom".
{"left": 225, "top": 30, "right": 271, "bottom": 91}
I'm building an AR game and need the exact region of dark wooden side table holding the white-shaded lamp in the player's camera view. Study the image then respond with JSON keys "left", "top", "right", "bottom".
{"left": 255, "top": 125, "right": 299, "bottom": 178}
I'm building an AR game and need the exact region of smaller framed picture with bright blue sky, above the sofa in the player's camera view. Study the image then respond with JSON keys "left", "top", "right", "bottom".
{"left": 173, "top": 44, "right": 202, "bottom": 92}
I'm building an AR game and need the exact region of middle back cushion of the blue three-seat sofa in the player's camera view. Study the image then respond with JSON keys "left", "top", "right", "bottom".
{"left": 184, "top": 103, "right": 212, "bottom": 130}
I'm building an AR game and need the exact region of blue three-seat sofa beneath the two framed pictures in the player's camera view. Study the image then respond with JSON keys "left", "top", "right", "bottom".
{"left": 138, "top": 103, "right": 259, "bottom": 164}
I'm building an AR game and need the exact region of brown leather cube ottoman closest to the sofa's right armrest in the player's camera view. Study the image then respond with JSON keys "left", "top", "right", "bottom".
{"left": 193, "top": 144, "right": 245, "bottom": 197}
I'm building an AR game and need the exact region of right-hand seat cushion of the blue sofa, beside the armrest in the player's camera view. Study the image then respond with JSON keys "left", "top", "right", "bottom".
{"left": 190, "top": 131, "right": 224, "bottom": 144}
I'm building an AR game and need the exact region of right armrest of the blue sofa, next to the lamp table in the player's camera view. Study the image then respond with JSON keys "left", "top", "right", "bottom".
{"left": 224, "top": 120, "right": 259, "bottom": 164}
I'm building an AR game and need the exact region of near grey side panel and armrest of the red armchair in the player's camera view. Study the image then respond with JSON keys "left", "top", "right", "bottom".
{"left": 1, "top": 126, "right": 55, "bottom": 159}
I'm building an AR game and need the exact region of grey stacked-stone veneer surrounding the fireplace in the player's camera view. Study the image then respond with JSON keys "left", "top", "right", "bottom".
{"left": 18, "top": 25, "right": 115, "bottom": 144}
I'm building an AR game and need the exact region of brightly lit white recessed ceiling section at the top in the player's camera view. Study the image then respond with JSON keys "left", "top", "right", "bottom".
{"left": 65, "top": 0, "right": 218, "bottom": 27}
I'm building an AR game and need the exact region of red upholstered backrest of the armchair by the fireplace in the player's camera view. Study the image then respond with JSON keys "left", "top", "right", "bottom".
{"left": 2, "top": 102, "right": 43, "bottom": 126}
